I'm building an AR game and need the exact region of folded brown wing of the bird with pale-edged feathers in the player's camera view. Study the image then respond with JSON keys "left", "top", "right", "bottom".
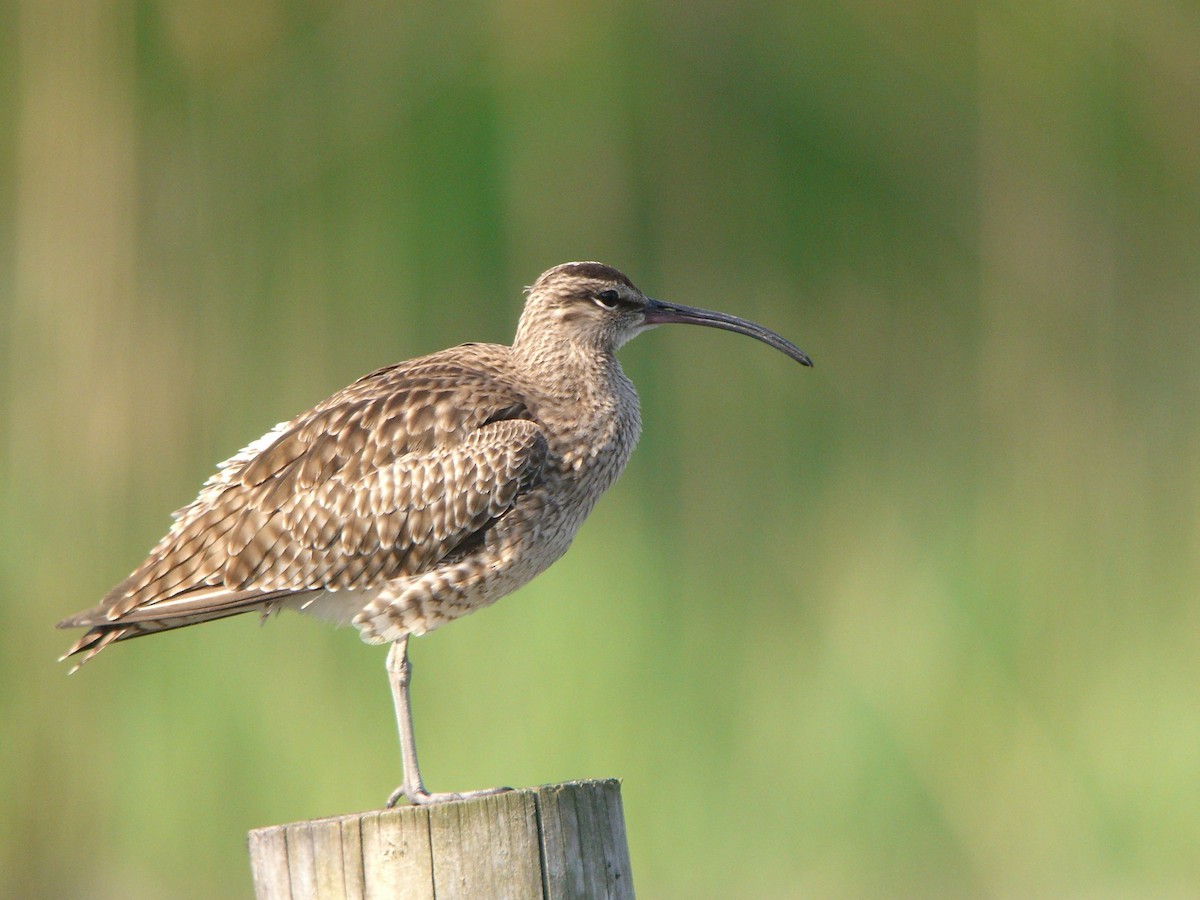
{"left": 60, "top": 346, "right": 546, "bottom": 655}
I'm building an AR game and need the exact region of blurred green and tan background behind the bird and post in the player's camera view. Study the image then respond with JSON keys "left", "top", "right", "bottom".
{"left": 0, "top": 0, "right": 1200, "bottom": 898}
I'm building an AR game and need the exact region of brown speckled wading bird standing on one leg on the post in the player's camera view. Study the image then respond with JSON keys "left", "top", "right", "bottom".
{"left": 59, "top": 262, "right": 812, "bottom": 806}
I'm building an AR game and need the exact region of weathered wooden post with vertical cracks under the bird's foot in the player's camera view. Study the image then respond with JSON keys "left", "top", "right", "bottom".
{"left": 250, "top": 779, "right": 634, "bottom": 900}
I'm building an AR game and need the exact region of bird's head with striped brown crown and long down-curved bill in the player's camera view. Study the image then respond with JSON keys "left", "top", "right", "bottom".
{"left": 514, "top": 263, "right": 812, "bottom": 366}
